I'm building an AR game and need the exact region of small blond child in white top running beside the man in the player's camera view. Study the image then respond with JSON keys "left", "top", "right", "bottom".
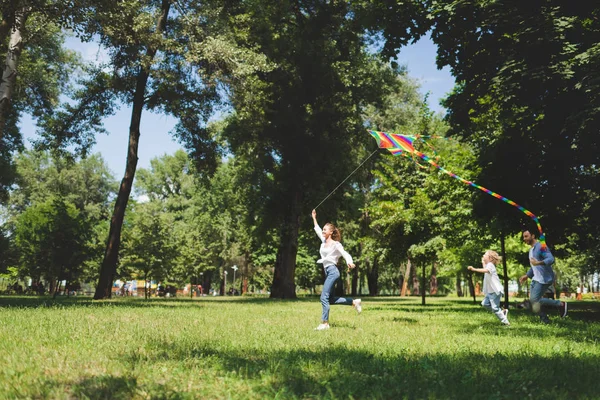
{"left": 468, "top": 250, "right": 510, "bottom": 326}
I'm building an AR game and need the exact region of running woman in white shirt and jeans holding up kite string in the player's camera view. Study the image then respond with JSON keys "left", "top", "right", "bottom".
{"left": 312, "top": 210, "right": 362, "bottom": 331}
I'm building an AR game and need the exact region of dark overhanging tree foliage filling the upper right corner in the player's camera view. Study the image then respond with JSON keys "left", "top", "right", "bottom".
{"left": 428, "top": 1, "right": 600, "bottom": 256}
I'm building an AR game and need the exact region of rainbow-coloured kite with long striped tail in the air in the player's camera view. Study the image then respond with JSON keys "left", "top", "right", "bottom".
{"left": 369, "top": 130, "right": 546, "bottom": 249}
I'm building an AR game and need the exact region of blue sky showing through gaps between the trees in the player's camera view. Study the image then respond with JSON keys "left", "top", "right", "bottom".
{"left": 21, "top": 37, "right": 454, "bottom": 180}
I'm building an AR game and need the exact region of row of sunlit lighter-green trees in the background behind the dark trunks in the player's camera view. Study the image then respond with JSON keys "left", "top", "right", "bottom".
{"left": 4, "top": 111, "right": 596, "bottom": 295}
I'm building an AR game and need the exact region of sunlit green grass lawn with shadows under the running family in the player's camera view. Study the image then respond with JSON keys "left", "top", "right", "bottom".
{"left": 0, "top": 297, "right": 600, "bottom": 399}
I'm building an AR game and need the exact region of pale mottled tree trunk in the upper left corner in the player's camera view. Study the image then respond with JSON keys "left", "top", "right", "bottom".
{"left": 0, "top": 7, "right": 31, "bottom": 140}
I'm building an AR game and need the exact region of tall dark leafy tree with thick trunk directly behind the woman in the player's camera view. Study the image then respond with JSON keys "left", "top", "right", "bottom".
{"left": 225, "top": 1, "right": 432, "bottom": 298}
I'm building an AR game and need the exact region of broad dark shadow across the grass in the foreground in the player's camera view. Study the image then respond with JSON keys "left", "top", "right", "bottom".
{"left": 110, "top": 333, "right": 600, "bottom": 399}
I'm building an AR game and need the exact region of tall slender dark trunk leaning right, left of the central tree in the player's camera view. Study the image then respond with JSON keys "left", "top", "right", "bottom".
{"left": 94, "top": 0, "right": 171, "bottom": 300}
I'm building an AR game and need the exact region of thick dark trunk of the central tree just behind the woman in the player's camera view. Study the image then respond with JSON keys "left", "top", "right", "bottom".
{"left": 270, "top": 187, "right": 302, "bottom": 299}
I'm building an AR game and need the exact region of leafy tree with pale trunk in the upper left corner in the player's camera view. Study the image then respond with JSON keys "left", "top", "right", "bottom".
{"left": 0, "top": 9, "right": 80, "bottom": 201}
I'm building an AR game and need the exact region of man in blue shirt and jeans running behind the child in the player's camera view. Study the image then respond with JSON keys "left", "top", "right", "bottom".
{"left": 519, "top": 229, "right": 567, "bottom": 324}
